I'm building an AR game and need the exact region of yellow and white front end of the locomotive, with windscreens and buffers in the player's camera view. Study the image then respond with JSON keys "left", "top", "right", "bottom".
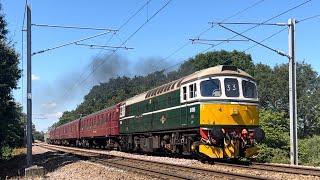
{"left": 192, "top": 66, "right": 264, "bottom": 158}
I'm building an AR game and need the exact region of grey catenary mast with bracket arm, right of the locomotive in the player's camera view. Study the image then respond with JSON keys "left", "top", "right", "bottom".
{"left": 209, "top": 19, "right": 298, "bottom": 165}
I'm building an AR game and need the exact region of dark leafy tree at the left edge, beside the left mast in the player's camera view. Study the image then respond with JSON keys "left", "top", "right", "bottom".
{"left": 0, "top": 3, "right": 23, "bottom": 158}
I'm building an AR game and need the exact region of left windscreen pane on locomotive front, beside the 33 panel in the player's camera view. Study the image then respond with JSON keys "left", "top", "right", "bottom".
{"left": 200, "top": 78, "right": 221, "bottom": 97}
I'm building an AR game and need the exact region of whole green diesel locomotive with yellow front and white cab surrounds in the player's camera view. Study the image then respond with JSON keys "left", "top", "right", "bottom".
{"left": 120, "top": 66, "right": 264, "bottom": 158}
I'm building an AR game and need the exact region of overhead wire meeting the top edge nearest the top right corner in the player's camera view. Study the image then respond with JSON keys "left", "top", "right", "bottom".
{"left": 165, "top": 0, "right": 312, "bottom": 71}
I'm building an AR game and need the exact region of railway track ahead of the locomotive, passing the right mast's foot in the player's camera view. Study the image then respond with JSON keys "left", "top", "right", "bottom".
{"left": 214, "top": 162, "right": 320, "bottom": 177}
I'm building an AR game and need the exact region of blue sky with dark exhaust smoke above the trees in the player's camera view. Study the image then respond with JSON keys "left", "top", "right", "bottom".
{"left": 1, "top": 0, "right": 320, "bottom": 131}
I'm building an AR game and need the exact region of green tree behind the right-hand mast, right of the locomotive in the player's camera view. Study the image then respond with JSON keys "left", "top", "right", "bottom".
{"left": 255, "top": 62, "right": 320, "bottom": 138}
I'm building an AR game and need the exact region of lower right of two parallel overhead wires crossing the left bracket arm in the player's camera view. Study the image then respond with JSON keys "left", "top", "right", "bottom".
{"left": 59, "top": 0, "right": 172, "bottom": 107}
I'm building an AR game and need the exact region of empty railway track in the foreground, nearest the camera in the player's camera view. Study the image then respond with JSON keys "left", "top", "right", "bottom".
{"left": 37, "top": 144, "right": 270, "bottom": 179}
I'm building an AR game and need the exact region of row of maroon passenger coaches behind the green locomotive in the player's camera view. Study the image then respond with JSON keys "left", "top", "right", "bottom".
{"left": 49, "top": 104, "right": 120, "bottom": 148}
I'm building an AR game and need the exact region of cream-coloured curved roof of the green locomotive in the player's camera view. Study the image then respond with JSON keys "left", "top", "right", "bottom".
{"left": 125, "top": 65, "right": 253, "bottom": 105}
